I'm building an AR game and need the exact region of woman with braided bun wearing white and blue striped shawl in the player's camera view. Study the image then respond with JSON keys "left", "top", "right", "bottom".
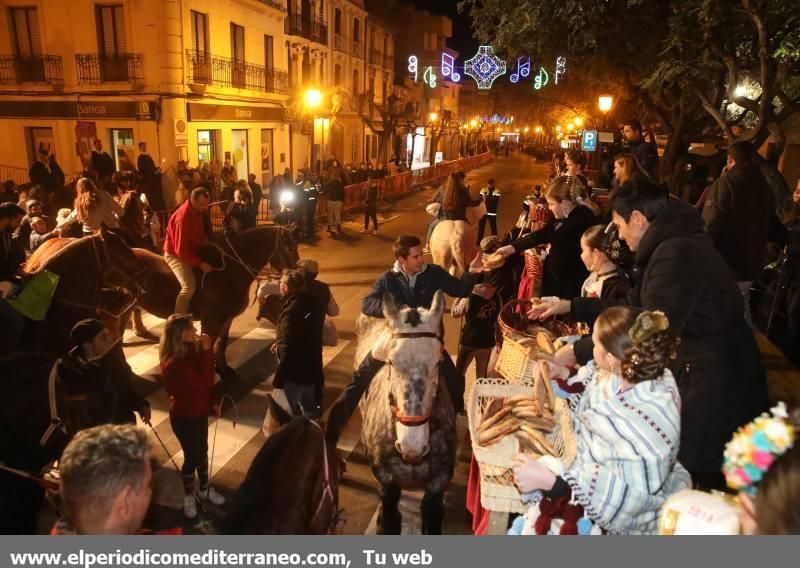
{"left": 514, "top": 307, "right": 690, "bottom": 534}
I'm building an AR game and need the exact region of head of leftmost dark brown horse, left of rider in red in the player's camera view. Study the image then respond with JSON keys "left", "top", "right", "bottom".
{"left": 96, "top": 225, "right": 152, "bottom": 295}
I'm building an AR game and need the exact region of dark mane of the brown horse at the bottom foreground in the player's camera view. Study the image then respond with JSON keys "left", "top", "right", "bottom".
{"left": 222, "top": 416, "right": 316, "bottom": 534}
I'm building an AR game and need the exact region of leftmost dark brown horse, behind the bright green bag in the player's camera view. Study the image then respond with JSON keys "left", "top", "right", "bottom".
{"left": 21, "top": 228, "right": 150, "bottom": 355}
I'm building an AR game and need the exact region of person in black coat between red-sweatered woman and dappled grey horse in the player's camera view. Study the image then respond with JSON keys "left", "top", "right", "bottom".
{"left": 272, "top": 270, "right": 325, "bottom": 418}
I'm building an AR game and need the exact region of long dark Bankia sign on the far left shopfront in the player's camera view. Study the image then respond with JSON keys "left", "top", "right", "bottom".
{"left": 0, "top": 101, "right": 158, "bottom": 120}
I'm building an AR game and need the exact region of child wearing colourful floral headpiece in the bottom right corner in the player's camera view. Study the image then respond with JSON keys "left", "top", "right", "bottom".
{"left": 722, "top": 403, "right": 800, "bottom": 535}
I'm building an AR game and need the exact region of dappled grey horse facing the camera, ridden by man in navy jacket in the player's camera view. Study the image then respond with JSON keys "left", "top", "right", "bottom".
{"left": 356, "top": 291, "right": 456, "bottom": 534}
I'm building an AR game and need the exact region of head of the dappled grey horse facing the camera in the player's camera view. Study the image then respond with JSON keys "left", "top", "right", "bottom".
{"left": 383, "top": 291, "right": 444, "bottom": 463}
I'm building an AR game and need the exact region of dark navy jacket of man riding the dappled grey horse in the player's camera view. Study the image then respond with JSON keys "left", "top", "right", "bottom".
{"left": 361, "top": 263, "right": 475, "bottom": 318}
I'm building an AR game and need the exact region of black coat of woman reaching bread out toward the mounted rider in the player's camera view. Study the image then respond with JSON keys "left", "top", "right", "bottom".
{"left": 511, "top": 205, "right": 596, "bottom": 298}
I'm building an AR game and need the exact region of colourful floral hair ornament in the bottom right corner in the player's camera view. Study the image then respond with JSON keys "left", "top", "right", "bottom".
{"left": 722, "top": 402, "right": 797, "bottom": 497}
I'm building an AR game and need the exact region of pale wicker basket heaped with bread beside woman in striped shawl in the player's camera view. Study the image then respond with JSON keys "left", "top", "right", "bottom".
{"left": 467, "top": 363, "right": 576, "bottom": 513}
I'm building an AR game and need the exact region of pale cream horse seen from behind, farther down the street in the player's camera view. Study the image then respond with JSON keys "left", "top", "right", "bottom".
{"left": 431, "top": 203, "right": 486, "bottom": 278}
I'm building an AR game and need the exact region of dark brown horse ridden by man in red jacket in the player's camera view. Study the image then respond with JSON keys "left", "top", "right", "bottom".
{"left": 127, "top": 226, "right": 299, "bottom": 379}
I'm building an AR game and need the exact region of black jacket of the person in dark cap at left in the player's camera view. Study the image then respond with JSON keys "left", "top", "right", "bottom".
{"left": 56, "top": 343, "right": 149, "bottom": 429}
